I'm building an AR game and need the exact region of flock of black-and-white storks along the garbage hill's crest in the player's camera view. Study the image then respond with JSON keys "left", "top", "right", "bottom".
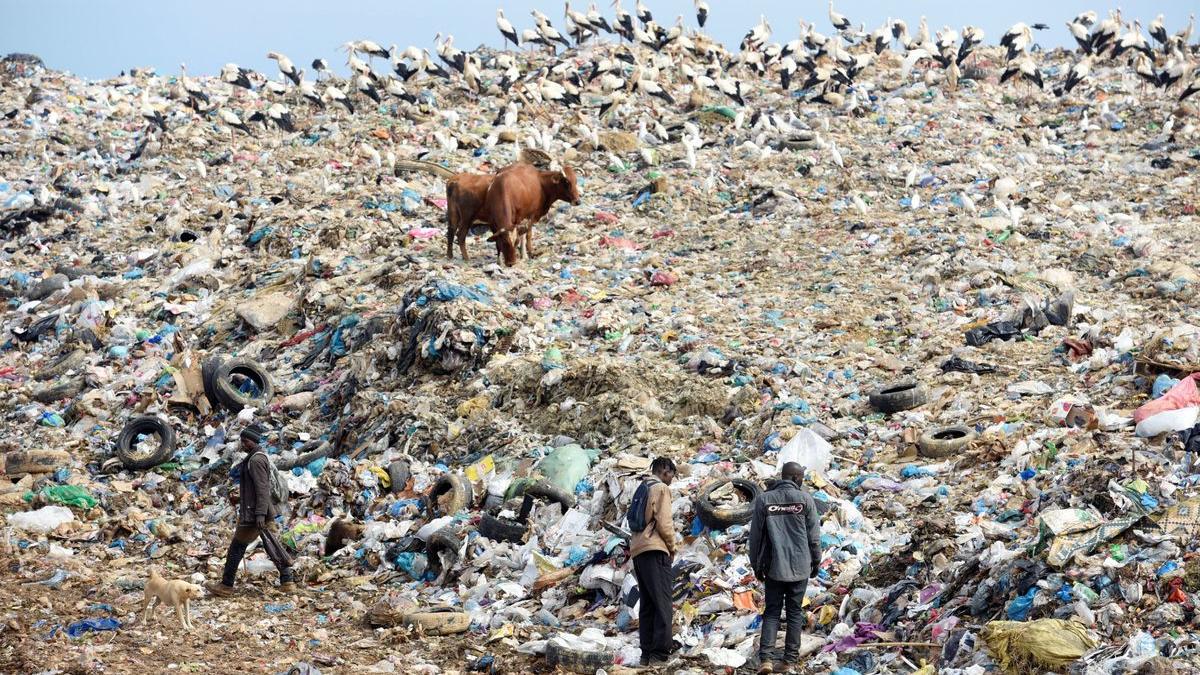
{"left": 133, "top": 0, "right": 1200, "bottom": 156}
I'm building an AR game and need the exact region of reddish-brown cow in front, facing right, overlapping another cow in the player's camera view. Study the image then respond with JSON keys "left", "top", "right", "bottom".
{"left": 484, "top": 163, "right": 580, "bottom": 267}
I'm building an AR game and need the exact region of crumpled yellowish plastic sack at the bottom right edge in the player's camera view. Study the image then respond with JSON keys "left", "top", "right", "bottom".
{"left": 980, "top": 619, "right": 1097, "bottom": 675}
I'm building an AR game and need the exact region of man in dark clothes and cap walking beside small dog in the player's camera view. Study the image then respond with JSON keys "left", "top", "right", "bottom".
{"left": 208, "top": 425, "right": 295, "bottom": 597}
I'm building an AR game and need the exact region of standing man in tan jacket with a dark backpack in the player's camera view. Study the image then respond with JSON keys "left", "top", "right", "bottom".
{"left": 629, "top": 458, "right": 676, "bottom": 665}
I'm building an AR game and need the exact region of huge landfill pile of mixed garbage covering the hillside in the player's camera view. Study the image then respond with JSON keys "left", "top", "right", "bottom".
{"left": 0, "top": 9, "right": 1200, "bottom": 675}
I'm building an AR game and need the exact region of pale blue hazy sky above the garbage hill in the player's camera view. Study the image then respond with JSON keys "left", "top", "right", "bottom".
{"left": 0, "top": 0, "right": 1200, "bottom": 78}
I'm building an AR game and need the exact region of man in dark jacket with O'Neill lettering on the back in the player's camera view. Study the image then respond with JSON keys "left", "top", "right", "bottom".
{"left": 750, "top": 461, "right": 821, "bottom": 673}
